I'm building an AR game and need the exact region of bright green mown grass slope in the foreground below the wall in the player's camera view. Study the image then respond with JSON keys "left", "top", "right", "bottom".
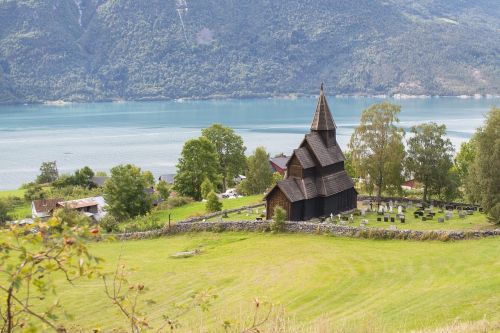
{"left": 51, "top": 233, "right": 500, "bottom": 332}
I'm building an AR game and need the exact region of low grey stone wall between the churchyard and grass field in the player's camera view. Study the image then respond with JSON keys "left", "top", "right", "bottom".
{"left": 114, "top": 221, "right": 500, "bottom": 241}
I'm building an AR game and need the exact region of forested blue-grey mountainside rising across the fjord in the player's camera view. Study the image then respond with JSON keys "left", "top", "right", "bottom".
{"left": 0, "top": 0, "right": 500, "bottom": 103}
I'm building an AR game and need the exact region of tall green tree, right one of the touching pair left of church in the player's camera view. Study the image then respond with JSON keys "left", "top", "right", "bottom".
{"left": 201, "top": 124, "right": 246, "bottom": 191}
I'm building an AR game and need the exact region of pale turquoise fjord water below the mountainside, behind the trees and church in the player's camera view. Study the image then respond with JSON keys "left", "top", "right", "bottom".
{"left": 0, "top": 97, "right": 500, "bottom": 189}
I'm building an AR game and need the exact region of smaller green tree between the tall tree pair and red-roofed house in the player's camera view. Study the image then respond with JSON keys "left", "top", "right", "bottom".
{"left": 241, "top": 147, "right": 273, "bottom": 195}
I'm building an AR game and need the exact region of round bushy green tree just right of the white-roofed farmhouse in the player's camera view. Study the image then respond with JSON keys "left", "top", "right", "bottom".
{"left": 104, "top": 164, "right": 152, "bottom": 221}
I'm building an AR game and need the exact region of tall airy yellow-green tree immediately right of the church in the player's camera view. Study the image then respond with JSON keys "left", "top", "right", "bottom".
{"left": 349, "top": 102, "right": 405, "bottom": 203}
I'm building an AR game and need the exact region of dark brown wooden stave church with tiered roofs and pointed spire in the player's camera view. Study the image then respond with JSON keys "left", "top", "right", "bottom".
{"left": 265, "top": 84, "right": 357, "bottom": 221}
